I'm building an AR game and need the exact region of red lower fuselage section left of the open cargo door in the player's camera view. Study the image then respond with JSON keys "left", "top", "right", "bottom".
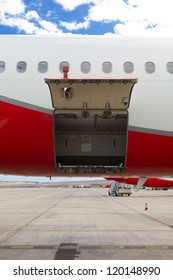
{"left": 0, "top": 101, "right": 56, "bottom": 176}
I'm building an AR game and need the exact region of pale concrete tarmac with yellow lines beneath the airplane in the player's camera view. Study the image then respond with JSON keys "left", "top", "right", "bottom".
{"left": 0, "top": 185, "right": 173, "bottom": 260}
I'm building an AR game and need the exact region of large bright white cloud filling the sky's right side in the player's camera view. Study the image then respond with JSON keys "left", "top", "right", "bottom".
{"left": 87, "top": 0, "right": 173, "bottom": 35}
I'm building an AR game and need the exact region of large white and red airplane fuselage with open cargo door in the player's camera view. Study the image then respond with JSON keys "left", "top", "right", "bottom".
{"left": 0, "top": 35, "right": 173, "bottom": 185}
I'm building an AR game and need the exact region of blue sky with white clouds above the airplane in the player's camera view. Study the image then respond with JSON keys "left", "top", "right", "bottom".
{"left": 0, "top": 0, "right": 173, "bottom": 36}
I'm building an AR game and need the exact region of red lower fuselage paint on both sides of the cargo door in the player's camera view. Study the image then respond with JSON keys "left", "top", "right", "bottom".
{"left": 0, "top": 101, "right": 173, "bottom": 177}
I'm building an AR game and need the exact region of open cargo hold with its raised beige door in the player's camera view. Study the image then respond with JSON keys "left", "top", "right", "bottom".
{"left": 45, "top": 76, "right": 137, "bottom": 174}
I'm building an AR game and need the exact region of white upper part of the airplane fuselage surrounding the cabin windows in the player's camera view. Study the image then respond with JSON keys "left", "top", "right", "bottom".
{"left": 0, "top": 36, "right": 173, "bottom": 134}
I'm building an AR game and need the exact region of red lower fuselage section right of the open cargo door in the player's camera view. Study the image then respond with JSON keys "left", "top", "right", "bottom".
{"left": 126, "top": 131, "right": 173, "bottom": 176}
